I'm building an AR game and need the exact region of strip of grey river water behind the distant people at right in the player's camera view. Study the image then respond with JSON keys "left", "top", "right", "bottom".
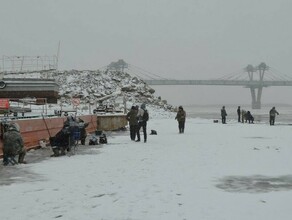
{"left": 184, "top": 104, "right": 292, "bottom": 125}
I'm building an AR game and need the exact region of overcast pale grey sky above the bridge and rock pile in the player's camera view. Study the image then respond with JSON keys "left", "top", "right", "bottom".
{"left": 0, "top": 0, "right": 292, "bottom": 105}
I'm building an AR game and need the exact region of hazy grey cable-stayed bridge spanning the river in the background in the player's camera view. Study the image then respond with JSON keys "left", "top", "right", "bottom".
{"left": 120, "top": 63, "right": 292, "bottom": 109}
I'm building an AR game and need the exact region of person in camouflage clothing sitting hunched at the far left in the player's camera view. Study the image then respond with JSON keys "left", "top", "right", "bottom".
{"left": 3, "top": 123, "right": 26, "bottom": 166}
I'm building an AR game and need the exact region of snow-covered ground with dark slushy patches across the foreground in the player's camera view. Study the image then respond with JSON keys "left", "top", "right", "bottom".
{"left": 0, "top": 111, "right": 292, "bottom": 220}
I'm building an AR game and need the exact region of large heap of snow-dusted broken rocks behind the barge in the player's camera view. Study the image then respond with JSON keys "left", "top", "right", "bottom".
{"left": 50, "top": 70, "right": 173, "bottom": 111}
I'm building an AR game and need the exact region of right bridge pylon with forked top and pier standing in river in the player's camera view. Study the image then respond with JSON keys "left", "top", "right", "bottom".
{"left": 245, "top": 63, "right": 269, "bottom": 109}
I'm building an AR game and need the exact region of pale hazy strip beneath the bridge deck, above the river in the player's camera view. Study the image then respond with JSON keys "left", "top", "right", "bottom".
{"left": 151, "top": 86, "right": 292, "bottom": 106}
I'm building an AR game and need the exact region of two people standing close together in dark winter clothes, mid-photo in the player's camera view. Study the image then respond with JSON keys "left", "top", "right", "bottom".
{"left": 127, "top": 103, "right": 149, "bottom": 143}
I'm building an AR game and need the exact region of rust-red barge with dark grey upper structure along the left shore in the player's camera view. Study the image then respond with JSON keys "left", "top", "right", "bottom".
{"left": 0, "top": 74, "right": 128, "bottom": 158}
